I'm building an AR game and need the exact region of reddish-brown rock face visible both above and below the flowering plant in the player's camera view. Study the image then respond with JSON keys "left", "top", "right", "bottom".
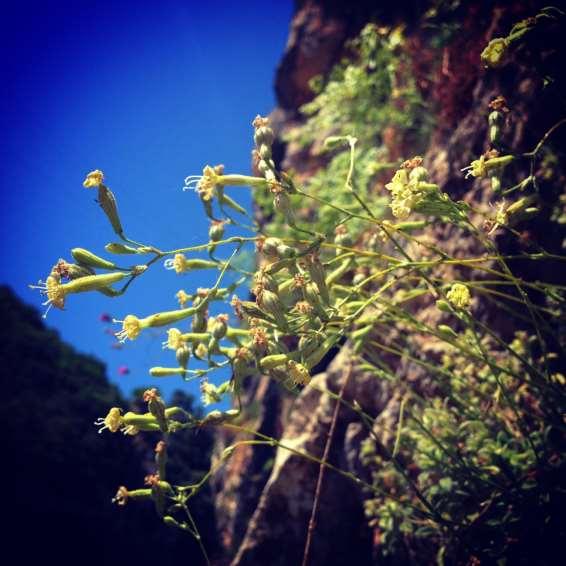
{"left": 213, "top": 0, "right": 561, "bottom": 566}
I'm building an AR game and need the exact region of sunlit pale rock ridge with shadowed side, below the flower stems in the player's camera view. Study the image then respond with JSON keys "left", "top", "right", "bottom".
{"left": 232, "top": 346, "right": 390, "bottom": 566}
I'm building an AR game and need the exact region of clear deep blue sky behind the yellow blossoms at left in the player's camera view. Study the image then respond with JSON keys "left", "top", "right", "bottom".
{"left": 0, "top": 0, "right": 292, "bottom": 402}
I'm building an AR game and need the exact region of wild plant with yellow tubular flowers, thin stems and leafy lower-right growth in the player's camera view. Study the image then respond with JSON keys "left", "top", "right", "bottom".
{"left": 31, "top": 8, "right": 566, "bottom": 562}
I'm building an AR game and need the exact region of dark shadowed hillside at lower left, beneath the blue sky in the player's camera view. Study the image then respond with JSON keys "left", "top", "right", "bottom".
{"left": 0, "top": 287, "right": 215, "bottom": 566}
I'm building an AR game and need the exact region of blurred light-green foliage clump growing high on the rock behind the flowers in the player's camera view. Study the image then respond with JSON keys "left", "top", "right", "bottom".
{"left": 254, "top": 24, "right": 432, "bottom": 236}
